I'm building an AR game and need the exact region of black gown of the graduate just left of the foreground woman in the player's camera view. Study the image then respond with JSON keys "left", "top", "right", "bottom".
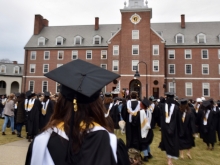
{"left": 39, "top": 100, "right": 54, "bottom": 130}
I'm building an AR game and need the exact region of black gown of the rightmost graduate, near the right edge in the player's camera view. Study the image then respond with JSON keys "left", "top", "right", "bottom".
{"left": 198, "top": 109, "right": 216, "bottom": 144}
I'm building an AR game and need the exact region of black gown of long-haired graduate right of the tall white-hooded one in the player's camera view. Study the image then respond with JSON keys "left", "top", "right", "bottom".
{"left": 179, "top": 112, "right": 195, "bottom": 150}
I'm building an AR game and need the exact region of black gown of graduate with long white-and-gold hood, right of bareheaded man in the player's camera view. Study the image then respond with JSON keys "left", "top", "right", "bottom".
{"left": 132, "top": 111, "right": 154, "bottom": 151}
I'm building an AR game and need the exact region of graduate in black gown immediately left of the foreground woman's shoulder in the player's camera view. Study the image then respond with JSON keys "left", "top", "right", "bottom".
{"left": 39, "top": 92, "right": 54, "bottom": 130}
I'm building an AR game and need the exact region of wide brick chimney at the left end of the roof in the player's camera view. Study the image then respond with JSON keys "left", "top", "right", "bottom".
{"left": 34, "top": 14, "right": 49, "bottom": 35}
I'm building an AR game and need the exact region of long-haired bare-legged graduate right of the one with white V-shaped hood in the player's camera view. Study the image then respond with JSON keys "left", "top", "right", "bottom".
{"left": 179, "top": 99, "right": 195, "bottom": 159}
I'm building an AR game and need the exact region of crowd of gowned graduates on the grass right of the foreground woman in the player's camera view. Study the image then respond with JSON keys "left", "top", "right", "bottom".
{"left": 102, "top": 91, "right": 220, "bottom": 165}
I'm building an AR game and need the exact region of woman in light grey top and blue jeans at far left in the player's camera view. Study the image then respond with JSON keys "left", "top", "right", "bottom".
{"left": 2, "top": 93, "right": 16, "bottom": 135}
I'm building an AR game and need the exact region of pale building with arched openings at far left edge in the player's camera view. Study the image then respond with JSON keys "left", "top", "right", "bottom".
{"left": 0, "top": 61, "right": 24, "bottom": 95}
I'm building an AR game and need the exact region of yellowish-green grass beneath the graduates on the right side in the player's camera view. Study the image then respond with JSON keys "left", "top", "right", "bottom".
{"left": 118, "top": 128, "right": 220, "bottom": 165}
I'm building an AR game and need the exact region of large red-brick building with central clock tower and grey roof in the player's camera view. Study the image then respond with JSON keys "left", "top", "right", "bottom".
{"left": 23, "top": 0, "right": 220, "bottom": 99}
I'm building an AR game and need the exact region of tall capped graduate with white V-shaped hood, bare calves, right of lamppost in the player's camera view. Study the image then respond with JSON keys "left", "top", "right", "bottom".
{"left": 159, "top": 92, "right": 180, "bottom": 165}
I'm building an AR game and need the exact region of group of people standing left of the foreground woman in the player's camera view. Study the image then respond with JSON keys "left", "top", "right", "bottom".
{"left": 0, "top": 91, "right": 58, "bottom": 142}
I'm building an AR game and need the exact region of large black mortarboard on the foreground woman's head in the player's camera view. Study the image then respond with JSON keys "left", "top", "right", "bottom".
{"left": 45, "top": 59, "right": 120, "bottom": 103}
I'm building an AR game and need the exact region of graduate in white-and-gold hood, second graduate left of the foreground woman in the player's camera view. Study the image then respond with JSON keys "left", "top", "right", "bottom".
{"left": 24, "top": 90, "right": 42, "bottom": 142}
